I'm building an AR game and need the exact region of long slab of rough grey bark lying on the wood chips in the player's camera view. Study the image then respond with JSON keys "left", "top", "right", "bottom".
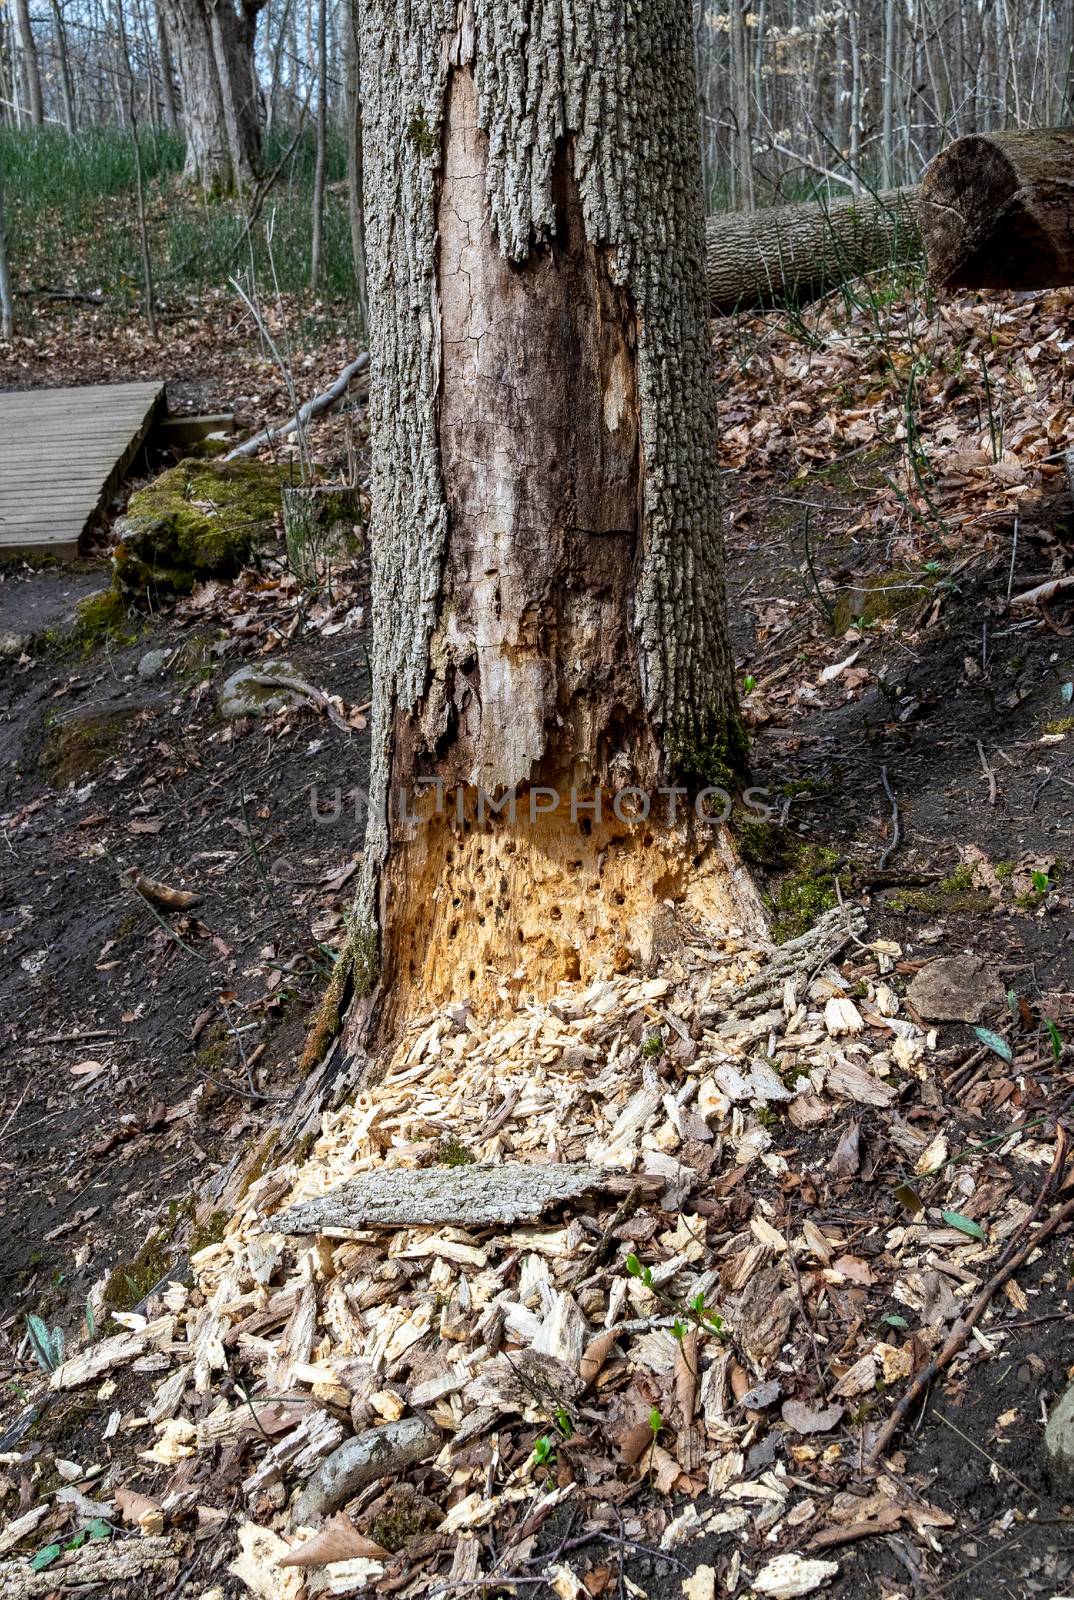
{"left": 264, "top": 1162, "right": 643, "bottom": 1234}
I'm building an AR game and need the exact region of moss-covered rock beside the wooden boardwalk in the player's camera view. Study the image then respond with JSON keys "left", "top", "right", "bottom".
{"left": 112, "top": 459, "right": 290, "bottom": 594}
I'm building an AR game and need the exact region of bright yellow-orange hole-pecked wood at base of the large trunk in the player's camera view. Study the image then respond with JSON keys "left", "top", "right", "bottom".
{"left": 383, "top": 789, "right": 763, "bottom": 1034}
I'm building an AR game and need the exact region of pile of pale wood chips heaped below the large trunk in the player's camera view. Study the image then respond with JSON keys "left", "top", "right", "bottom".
{"left": 0, "top": 907, "right": 1069, "bottom": 1600}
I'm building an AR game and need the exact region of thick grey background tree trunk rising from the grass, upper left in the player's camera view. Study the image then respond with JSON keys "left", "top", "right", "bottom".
{"left": 163, "top": 0, "right": 264, "bottom": 192}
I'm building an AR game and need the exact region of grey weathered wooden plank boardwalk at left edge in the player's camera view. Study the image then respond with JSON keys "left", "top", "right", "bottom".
{"left": 0, "top": 384, "right": 163, "bottom": 557}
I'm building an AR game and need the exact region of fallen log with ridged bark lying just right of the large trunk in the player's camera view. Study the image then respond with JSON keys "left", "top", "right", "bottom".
{"left": 706, "top": 189, "right": 922, "bottom": 314}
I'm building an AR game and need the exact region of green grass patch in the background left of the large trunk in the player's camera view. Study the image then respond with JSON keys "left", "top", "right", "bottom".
{"left": 0, "top": 128, "right": 361, "bottom": 312}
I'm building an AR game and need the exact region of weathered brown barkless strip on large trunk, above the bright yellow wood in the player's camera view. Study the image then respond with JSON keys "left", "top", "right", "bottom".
{"left": 416, "top": 69, "right": 656, "bottom": 792}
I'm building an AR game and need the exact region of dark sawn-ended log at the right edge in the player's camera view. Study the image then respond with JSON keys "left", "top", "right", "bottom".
{"left": 920, "top": 128, "right": 1074, "bottom": 290}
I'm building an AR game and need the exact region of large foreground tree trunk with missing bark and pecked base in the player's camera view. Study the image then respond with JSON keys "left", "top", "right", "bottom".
{"left": 334, "top": 0, "right": 744, "bottom": 1062}
